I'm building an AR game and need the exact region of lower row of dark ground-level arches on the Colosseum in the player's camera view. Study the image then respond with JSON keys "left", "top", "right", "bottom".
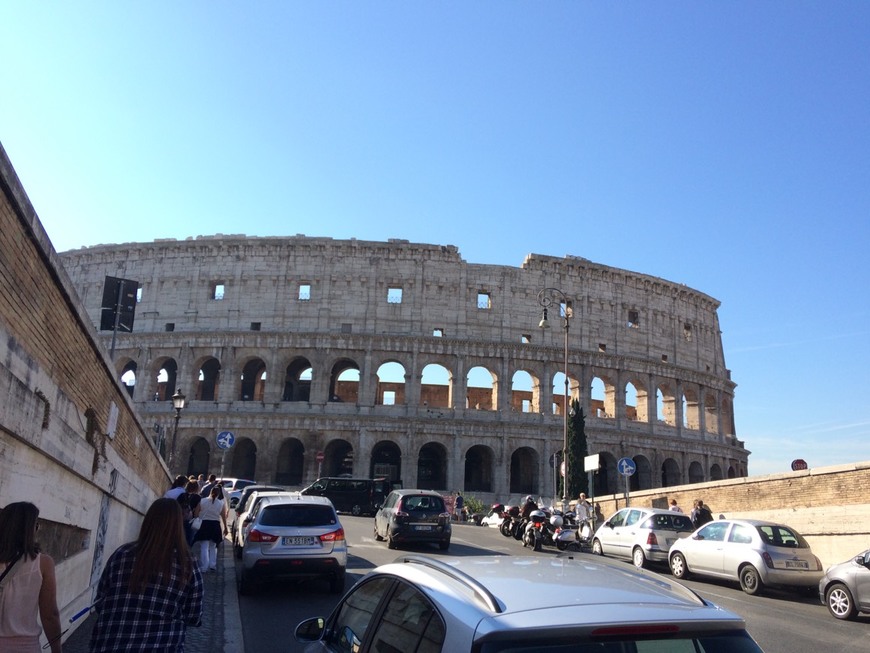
{"left": 179, "top": 437, "right": 740, "bottom": 498}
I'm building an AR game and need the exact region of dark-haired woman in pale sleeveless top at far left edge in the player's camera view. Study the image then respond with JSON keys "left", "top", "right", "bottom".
{"left": 0, "top": 501, "right": 61, "bottom": 653}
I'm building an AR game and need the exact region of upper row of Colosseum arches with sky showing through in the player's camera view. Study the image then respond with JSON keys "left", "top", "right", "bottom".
{"left": 120, "top": 356, "right": 734, "bottom": 435}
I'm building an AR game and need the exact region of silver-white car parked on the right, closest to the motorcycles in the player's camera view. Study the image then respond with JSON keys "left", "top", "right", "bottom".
{"left": 592, "top": 508, "right": 695, "bottom": 567}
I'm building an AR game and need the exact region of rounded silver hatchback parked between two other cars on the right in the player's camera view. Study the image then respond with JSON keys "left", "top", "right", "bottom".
{"left": 669, "top": 519, "right": 824, "bottom": 594}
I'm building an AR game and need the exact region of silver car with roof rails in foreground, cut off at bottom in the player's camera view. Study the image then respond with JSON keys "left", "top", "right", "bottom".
{"left": 296, "top": 554, "right": 761, "bottom": 653}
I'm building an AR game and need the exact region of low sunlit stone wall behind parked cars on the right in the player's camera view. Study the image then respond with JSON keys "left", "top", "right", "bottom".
{"left": 595, "top": 462, "right": 870, "bottom": 567}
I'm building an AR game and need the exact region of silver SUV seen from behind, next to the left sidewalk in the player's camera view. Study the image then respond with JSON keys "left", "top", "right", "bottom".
{"left": 239, "top": 494, "right": 347, "bottom": 594}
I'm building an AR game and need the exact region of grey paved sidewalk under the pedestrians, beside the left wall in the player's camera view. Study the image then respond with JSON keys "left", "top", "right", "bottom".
{"left": 61, "top": 540, "right": 245, "bottom": 653}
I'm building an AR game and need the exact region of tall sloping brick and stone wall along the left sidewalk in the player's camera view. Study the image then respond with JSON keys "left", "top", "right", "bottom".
{"left": 0, "top": 147, "right": 169, "bottom": 636}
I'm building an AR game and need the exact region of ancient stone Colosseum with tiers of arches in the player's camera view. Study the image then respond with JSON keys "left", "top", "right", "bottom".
{"left": 61, "top": 235, "right": 749, "bottom": 501}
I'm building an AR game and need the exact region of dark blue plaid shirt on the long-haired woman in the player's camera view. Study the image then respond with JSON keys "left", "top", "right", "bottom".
{"left": 91, "top": 542, "right": 203, "bottom": 653}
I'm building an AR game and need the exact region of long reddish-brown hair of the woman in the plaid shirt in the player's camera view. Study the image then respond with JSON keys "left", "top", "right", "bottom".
{"left": 129, "top": 499, "right": 193, "bottom": 594}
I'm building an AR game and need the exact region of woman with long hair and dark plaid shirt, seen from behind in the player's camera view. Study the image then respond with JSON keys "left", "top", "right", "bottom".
{"left": 91, "top": 498, "right": 203, "bottom": 653}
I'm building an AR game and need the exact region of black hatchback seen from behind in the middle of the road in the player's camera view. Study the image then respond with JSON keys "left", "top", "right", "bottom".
{"left": 375, "top": 488, "right": 452, "bottom": 551}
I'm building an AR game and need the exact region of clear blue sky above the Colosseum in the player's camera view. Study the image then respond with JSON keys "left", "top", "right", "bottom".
{"left": 0, "top": 0, "right": 870, "bottom": 475}
